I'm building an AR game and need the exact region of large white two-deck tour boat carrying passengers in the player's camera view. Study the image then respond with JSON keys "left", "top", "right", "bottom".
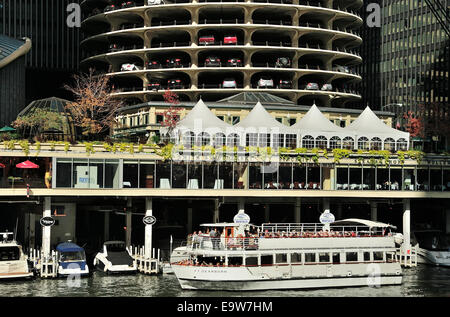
{"left": 171, "top": 217, "right": 402, "bottom": 291}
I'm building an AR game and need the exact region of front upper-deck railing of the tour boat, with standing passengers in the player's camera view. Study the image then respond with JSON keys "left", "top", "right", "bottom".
{"left": 187, "top": 235, "right": 259, "bottom": 250}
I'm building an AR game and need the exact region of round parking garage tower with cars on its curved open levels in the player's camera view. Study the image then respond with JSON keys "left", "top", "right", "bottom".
{"left": 82, "top": 0, "right": 362, "bottom": 107}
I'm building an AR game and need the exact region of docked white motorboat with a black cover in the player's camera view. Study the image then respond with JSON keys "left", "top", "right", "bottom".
{"left": 94, "top": 241, "right": 137, "bottom": 273}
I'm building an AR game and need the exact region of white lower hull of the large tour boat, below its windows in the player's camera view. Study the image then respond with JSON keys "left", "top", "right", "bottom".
{"left": 172, "top": 263, "right": 402, "bottom": 291}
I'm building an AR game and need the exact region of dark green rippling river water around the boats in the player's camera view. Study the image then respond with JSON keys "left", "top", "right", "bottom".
{"left": 0, "top": 265, "right": 450, "bottom": 297}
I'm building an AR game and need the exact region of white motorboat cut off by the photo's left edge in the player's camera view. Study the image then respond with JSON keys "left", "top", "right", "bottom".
{"left": 0, "top": 232, "right": 33, "bottom": 279}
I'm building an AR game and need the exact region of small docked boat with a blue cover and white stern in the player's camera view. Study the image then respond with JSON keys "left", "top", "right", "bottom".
{"left": 56, "top": 242, "right": 89, "bottom": 276}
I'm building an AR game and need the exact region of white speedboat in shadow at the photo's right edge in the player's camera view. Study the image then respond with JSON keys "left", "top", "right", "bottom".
{"left": 413, "top": 230, "right": 450, "bottom": 267}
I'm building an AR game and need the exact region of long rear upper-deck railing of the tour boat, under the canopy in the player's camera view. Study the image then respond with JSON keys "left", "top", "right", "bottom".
{"left": 261, "top": 223, "right": 388, "bottom": 238}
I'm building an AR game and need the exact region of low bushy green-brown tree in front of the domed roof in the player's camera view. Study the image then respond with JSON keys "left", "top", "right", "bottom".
{"left": 12, "top": 108, "right": 65, "bottom": 139}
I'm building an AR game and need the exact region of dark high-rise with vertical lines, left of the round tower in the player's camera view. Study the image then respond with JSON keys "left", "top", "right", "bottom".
{"left": 0, "top": 0, "right": 81, "bottom": 103}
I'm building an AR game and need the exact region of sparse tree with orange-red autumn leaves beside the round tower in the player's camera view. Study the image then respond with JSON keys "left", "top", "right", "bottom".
{"left": 64, "top": 68, "right": 123, "bottom": 139}
